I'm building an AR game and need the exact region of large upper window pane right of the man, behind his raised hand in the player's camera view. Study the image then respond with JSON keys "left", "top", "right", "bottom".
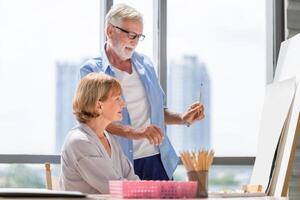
{"left": 167, "top": 0, "right": 266, "bottom": 156}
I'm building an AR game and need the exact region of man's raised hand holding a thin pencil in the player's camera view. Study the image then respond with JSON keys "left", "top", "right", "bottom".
{"left": 182, "top": 101, "right": 205, "bottom": 124}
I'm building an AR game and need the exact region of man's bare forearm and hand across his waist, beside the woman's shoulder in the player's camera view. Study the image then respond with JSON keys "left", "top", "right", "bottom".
{"left": 106, "top": 122, "right": 164, "bottom": 145}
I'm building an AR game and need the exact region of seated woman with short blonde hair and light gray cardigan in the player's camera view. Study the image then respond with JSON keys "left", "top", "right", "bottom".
{"left": 59, "top": 73, "right": 139, "bottom": 194}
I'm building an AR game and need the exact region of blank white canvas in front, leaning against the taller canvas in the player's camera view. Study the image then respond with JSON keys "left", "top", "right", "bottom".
{"left": 250, "top": 78, "right": 296, "bottom": 190}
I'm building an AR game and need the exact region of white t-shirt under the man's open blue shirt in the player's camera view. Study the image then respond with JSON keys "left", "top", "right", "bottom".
{"left": 113, "top": 67, "right": 159, "bottom": 159}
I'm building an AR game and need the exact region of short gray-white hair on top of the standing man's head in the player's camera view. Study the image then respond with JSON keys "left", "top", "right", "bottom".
{"left": 105, "top": 4, "right": 143, "bottom": 29}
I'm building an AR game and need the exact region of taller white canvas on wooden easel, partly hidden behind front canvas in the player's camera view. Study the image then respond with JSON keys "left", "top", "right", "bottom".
{"left": 269, "top": 34, "right": 300, "bottom": 196}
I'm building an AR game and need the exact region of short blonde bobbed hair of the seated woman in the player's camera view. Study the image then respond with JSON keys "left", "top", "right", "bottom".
{"left": 73, "top": 73, "right": 122, "bottom": 123}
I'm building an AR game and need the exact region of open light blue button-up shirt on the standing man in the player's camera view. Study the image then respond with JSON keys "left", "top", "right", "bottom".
{"left": 80, "top": 45, "right": 178, "bottom": 179}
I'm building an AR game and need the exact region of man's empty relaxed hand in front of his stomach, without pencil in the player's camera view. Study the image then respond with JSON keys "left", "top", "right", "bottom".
{"left": 131, "top": 125, "right": 164, "bottom": 145}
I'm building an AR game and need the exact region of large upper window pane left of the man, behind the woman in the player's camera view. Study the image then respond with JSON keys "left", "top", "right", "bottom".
{"left": 0, "top": 0, "right": 100, "bottom": 154}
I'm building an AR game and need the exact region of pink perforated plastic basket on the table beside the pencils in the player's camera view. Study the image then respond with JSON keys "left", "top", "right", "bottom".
{"left": 109, "top": 181, "right": 197, "bottom": 198}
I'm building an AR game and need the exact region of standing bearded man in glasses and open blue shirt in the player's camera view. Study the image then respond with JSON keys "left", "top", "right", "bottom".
{"left": 80, "top": 4, "right": 204, "bottom": 180}
